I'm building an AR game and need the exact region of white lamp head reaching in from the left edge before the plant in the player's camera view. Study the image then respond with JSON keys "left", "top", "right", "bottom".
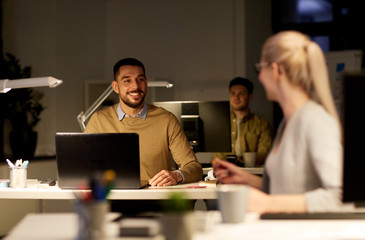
{"left": 0, "top": 77, "right": 63, "bottom": 93}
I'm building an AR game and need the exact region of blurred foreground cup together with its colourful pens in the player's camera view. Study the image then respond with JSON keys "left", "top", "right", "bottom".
{"left": 75, "top": 170, "right": 115, "bottom": 240}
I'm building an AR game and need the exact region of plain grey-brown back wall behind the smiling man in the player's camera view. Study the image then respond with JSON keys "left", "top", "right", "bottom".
{"left": 3, "top": 0, "right": 271, "bottom": 155}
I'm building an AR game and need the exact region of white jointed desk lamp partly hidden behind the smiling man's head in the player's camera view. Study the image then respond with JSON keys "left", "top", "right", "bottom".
{"left": 77, "top": 81, "right": 173, "bottom": 131}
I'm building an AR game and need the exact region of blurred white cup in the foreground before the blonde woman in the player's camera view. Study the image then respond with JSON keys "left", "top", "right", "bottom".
{"left": 217, "top": 184, "right": 249, "bottom": 223}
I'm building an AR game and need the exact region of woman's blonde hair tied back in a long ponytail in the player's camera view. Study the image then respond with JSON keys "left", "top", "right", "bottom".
{"left": 262, "top": 31, "right": 339, "bottom": 121}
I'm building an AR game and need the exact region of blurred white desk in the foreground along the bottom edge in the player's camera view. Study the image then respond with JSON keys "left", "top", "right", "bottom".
{"left": 5, "top": 213, "right": 365, "bottom": 240}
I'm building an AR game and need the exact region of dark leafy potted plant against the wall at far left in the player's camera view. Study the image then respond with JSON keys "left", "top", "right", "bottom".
{"left": 0, "top": 53, "right": 44, "bottom": 158}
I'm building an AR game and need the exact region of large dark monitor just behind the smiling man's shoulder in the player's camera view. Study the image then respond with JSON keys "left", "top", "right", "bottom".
{"left": 152, "top": 101, "right": 231, "bottom": 152}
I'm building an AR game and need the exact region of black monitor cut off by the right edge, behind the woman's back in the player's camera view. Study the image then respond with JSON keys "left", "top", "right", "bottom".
{"left": 343, "top": 72, "right": 365, "bottom": 206}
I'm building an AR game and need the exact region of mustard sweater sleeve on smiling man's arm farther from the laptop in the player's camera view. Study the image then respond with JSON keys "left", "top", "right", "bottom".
{"left": 168, "top": 114, "right": 203, "bottom": 183}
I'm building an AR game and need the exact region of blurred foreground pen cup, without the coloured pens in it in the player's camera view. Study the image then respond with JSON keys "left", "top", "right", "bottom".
{"left": 75, "top": 201, "right": 109, "bottom": 240}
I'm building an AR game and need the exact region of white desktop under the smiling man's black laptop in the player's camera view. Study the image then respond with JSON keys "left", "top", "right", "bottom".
{"left": 0, "top": 183, "right": 217, "bottom": 200}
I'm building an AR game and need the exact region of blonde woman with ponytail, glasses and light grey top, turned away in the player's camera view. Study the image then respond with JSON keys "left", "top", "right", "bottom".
{"left": 213, "top": 31, "right": 352, "bottom": 213}
